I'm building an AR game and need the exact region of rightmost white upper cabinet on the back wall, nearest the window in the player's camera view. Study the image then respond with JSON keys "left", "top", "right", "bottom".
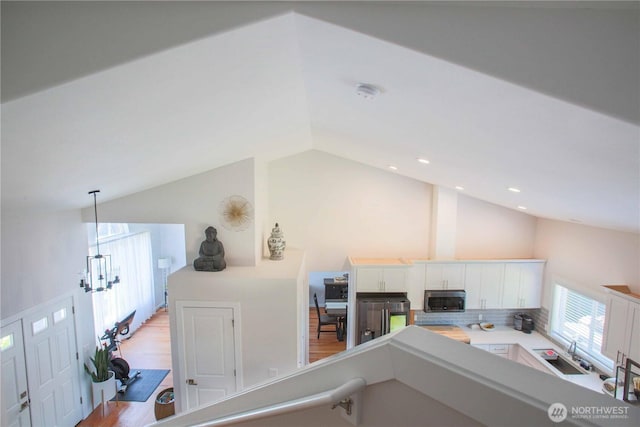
{"left": 502, "top": 260, "right": 544, "bottom": 308}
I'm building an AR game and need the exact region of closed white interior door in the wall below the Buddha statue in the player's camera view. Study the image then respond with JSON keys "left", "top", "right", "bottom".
{"left": 177, "top": 304, "right": 237, "bottom": 410}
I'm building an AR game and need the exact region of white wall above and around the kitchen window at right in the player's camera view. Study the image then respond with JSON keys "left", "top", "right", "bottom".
{"left": 534, "top": 219, "right": 640, "bottom": 308}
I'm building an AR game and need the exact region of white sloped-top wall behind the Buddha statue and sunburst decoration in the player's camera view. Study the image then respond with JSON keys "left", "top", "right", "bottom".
{"left": 82, "top": 159, "right": 256, "bottom": 265}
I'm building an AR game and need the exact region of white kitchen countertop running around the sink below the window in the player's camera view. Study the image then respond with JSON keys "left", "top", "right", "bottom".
{"left": 461, "top": 326, "right": 604, "bottom": 393}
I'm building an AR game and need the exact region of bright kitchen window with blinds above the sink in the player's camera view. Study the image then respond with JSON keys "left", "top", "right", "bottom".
{"left": 551, "top": 284, "right": 613, "bottom": 369}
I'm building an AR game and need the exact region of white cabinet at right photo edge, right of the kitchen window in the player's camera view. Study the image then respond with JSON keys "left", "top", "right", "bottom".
{"left": 602, "top": 293, "right": 640, "bottom": 364}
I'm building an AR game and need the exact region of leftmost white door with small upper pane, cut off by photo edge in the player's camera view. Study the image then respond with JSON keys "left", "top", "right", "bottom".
{"left": 0, "top": 320, "right": 31, "bottom": 427}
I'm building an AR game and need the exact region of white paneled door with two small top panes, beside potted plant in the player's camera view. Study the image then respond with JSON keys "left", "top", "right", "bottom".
{"left": 23, "top": 298, "right": 82, "bottom": 426}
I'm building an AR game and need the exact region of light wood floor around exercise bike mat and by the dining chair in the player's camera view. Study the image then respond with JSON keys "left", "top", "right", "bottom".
{"left": 78, "top": 308, "right": 346, "bottom": 427}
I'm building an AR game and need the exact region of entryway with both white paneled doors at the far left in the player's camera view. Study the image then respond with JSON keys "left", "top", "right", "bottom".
{"left": 0, "top": 297, "right": 82, "bottom": 426}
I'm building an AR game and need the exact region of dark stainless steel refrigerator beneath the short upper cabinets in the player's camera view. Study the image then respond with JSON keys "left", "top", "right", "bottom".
{"left": 356, "top": 293, "right": 411, "bottom": 345}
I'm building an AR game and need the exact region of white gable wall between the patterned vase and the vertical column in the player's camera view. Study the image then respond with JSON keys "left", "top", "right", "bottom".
{"left": 269, "top": 150, "right": 431, "bottom": 271}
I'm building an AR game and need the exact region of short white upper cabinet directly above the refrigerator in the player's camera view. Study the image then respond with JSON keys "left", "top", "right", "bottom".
{"left": 349, "top": 258, "right": 411, "bottom": 292}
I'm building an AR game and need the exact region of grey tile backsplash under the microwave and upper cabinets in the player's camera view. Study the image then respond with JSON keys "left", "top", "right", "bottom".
{"left": 414, "top": 309, "right": 544, "bottom": 330}
